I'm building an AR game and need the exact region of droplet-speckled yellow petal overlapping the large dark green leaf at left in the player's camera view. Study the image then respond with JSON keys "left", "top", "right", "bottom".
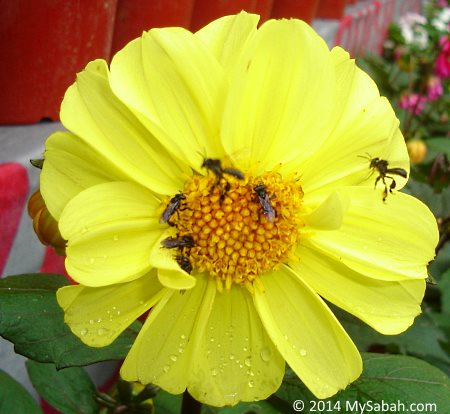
{"left": 56, "top": 271, "right": 164, "bottom": 347}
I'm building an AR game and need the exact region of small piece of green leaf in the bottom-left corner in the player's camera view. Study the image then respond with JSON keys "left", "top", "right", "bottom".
{"left": 0, "top": 369, "right": 42, "bottom": 414}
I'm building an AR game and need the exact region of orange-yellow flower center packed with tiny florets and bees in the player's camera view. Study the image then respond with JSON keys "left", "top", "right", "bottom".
{"left": 160, "top": 168, "right": 303, "bottom": 291}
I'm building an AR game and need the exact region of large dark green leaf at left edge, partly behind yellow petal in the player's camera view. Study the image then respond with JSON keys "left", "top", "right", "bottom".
{"left": 0, "top": 274, "right": 141, "bottom": 368}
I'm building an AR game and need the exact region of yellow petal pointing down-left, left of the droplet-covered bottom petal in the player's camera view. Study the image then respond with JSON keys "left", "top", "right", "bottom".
{"left": 120, "top": 277, "right": 216, "bottom": 394}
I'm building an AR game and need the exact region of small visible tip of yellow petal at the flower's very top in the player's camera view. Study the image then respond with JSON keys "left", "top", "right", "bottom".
{"left": 195, "top": 11, "right": 259, "bottom": 76}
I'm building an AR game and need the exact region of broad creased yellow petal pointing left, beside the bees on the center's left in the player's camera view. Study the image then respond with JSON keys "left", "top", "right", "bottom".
{"left": 59, "top": 182, "right": 162, "bottom": 286}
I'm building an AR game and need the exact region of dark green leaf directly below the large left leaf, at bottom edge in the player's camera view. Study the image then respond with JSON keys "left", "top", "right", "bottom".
{"left": 26, "top": 360, "right": 98, "bottom": 414}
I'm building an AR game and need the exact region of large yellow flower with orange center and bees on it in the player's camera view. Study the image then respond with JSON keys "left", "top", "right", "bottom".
{"left": 41, "top": 13, "right": 437, "bottom": 406}
